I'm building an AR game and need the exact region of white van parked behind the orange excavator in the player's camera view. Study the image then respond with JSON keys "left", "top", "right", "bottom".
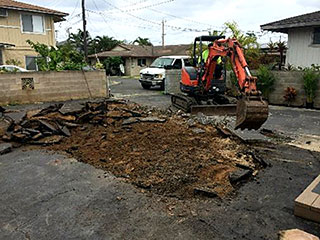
{"left": 139, "top": 56, "right": 191, "bottom": 89}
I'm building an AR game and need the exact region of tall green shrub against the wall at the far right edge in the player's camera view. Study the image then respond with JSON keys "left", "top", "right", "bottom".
{"left": 302, "top": 68, "right": 320, "bottom": 103}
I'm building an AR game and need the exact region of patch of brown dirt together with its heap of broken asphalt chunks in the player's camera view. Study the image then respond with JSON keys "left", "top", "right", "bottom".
{"left": 4, "top": 101, "right": 261, "bottom": 198}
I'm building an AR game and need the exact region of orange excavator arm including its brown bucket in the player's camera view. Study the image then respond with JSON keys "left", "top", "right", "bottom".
{"left": 198, "top": 38, "right": 268, "bottom": 130}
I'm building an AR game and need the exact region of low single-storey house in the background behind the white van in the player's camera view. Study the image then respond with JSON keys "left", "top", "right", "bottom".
{"left": 89, "top": 44, "right": 190, "bottom": 76}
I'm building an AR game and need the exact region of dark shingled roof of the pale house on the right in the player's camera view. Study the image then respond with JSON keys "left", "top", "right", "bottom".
{"left": 260, "top": 11, "right": 320, "bottom": 33}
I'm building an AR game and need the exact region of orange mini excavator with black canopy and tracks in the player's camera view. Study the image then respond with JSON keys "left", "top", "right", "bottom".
{"left": 171, "top": 36, "right": 268, "bottom": 130}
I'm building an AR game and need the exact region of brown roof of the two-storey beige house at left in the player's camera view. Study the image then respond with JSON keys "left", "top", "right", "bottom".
{"left": 0, "top": 0, "right": 68, "bottom": 21}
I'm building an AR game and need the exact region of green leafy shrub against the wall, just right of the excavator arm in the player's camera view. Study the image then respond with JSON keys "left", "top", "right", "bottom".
{"left": 257, "top": 65, "right": 276, "bottom": 99}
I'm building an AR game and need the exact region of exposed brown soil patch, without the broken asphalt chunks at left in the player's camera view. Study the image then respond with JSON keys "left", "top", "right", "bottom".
{"left": 48, "top": 101, "right": 259, "bottom": 198}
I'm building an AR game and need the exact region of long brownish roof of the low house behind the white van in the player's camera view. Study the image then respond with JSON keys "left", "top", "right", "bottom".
{"left": 89, "top": 44, "right": 190, "bottom": 58}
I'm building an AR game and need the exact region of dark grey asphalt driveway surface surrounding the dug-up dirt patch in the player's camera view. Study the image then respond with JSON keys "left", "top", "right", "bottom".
{"left": 0, "top": 79, "right": 320, "bottom": 240}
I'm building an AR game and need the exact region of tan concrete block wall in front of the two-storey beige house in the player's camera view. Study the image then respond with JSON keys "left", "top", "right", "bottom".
{"left": 0, "top": 70, "right": 109, "bottom": 105}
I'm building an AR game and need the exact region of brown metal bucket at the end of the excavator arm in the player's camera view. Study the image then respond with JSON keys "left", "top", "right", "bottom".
{"left": 235, "top": 96, "right": 269, "bottom": 130}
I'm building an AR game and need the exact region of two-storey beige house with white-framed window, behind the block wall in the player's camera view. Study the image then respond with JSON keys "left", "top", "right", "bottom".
{"left": 0, "top": 0, "right": 68, "bottom": 70}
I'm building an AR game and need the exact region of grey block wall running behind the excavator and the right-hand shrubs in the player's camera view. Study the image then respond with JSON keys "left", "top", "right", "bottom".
{"left": 165, "top": 70, "right": 320, "bottom": 108}
